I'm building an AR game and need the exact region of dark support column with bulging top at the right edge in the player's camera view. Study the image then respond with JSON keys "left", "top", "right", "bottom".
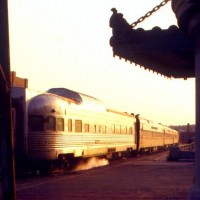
{"left": 172, "top": 0, "right": 200, "bottom": 200}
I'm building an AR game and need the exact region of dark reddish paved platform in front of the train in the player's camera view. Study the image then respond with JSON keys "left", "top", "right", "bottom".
{"left": 0, "top": 152, "right": 194, "bottom": 200}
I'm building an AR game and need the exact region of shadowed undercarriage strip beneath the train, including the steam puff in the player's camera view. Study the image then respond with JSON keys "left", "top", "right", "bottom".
{"left": 13, "top": 146, "right": 173, "bottom": 177}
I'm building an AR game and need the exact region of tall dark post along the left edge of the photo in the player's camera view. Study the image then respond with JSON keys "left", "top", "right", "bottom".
{"left": 0, "top": 0, "right": 16, "bottom": 200}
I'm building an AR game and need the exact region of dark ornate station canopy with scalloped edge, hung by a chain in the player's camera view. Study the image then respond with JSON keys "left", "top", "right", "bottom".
{"left": 110, "top": 10, "right": 195, "bottom": 79}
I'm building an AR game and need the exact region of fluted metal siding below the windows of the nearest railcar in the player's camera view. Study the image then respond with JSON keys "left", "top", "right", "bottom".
{"left": 28, "top": 132, "right": 135, "bottom": 159}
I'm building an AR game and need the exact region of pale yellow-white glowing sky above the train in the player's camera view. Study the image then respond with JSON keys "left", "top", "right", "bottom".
{"left": 8, "top": 0, "right": 195, "bottom": 125}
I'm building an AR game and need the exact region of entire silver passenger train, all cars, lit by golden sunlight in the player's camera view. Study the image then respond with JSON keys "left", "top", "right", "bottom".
{"left": 12, "top": 88, "right": 179, "bottom": 169}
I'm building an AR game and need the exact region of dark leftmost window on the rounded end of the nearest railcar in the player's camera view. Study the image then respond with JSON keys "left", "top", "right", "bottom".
{"left": 28, "top": 115, "right": 44, "bottom": 131}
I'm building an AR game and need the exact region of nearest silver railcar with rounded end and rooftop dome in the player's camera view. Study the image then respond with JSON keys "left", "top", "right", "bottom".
{"left": 27, "top": 89, "right": 136, "bottom": 163}
